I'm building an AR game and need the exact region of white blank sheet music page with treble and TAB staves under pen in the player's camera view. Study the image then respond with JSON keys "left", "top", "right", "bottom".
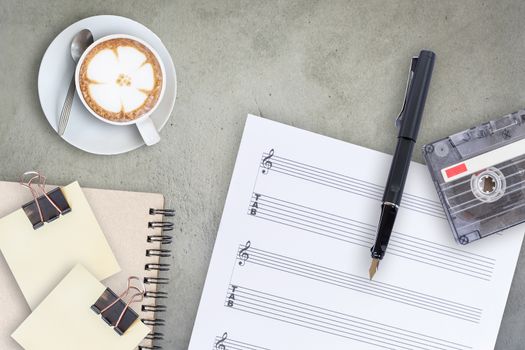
{"left": 189, "top": 116, "right": 524, "bottom": 350}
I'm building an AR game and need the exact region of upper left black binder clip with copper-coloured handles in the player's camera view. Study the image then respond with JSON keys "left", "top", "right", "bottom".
{"left": 20, "top": 171, "right": 71, "bottom": 230}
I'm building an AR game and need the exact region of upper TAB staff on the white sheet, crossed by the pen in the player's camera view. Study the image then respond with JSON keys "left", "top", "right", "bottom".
{"left": 248, "top": 193, "right": 495, "bottom": 281}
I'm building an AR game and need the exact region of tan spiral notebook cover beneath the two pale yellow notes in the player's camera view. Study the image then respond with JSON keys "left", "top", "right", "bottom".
{"left": 0, "top": 181, "right": 173, "bottom": 350}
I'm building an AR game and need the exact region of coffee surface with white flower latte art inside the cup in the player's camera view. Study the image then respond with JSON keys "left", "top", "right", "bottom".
{"left": 79, "top": 38, "right": 163, "bottom": 122}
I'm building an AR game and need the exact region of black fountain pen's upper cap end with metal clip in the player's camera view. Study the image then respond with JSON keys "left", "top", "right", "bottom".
{"left": 398, "top": 50, "right": 436, "bottom": 142}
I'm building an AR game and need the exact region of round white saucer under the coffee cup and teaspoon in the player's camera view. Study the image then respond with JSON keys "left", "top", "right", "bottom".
{"left": 38, "top": 16, "right": 177, "bottom": 154}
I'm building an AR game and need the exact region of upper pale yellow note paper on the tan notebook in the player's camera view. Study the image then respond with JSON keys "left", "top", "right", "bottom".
{"left": 0, "top": 182, "right": 120, "bottom": 310}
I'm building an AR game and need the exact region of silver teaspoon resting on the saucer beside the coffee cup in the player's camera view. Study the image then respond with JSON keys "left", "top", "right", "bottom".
{"left": 58, "top": 29, "right": 93, "bottom": 136}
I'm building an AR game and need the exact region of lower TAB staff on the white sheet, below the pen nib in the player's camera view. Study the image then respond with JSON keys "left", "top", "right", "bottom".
{"left": 224, "top": 285, "right": 472, "bottom": 350}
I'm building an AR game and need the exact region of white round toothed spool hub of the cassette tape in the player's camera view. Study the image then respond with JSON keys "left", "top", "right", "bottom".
{"left": 470, "top": 167, "right": 507, "bottom": 203}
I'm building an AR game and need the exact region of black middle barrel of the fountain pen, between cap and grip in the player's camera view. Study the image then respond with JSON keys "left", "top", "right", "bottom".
{"left": 383, "top": 137, "right": 415, "bottom": 206}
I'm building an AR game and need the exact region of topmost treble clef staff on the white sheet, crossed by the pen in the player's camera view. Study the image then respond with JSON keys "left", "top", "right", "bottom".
{"left": 260, "top": 149, "right": 446, "bottom": 220}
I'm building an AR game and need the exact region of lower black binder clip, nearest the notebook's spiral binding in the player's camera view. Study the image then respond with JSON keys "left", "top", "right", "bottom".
{"left": 91, "top": 276, "right": 146, "bottom": 335}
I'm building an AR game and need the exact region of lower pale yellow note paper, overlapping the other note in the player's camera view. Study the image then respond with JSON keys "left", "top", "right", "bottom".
{"left": 12, "top": 265, "right": 150, "bottom": 350}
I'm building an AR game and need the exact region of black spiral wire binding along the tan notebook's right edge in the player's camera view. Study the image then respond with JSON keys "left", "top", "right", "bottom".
{"left": 138, "top": 208, "right": 175, "bottom": 350}
